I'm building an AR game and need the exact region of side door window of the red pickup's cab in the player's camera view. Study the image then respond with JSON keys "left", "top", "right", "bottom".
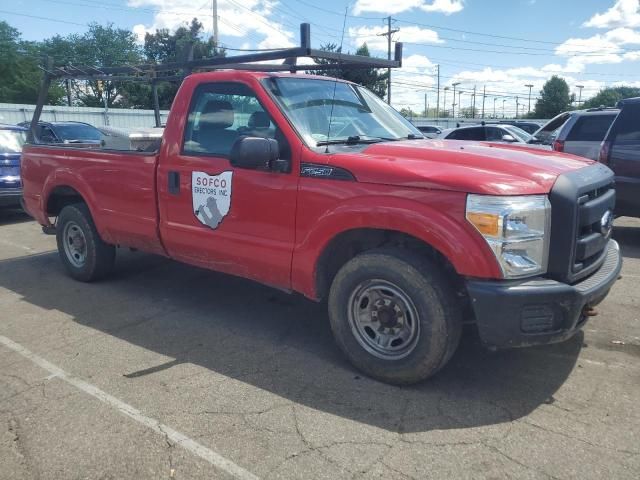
{"left": 183, "top": 83, "right": 289, "bottom": 158}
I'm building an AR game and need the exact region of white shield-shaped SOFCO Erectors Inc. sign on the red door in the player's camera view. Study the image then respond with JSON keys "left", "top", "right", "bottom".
{"left": 191, "top": 172, "right": 233, "bottom": 229}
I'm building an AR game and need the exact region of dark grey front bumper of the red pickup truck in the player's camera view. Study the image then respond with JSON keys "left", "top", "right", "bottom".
{"left": 467, "top": 240, "right": 622, "bottom": 348}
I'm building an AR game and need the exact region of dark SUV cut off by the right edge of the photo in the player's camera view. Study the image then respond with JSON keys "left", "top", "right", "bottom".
{"left": 600, "top": 97, "right": 640, "bottom": 217}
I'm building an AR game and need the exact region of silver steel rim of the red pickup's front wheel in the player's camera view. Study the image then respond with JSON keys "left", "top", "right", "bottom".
{"left": 348, "top": 280, "right": 420, "bottom": 360}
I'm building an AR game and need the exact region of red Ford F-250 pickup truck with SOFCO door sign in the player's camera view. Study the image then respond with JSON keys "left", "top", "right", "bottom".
{"left": 22, "top": 71, "right": 622, "bottom": 384}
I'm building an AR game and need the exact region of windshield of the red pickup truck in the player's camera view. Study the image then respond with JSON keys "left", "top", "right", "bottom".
{"left": 266, "top": 78, "right": 423, "bottom": 147}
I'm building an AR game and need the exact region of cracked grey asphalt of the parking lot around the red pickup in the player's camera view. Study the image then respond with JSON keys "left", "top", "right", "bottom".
{"left": 0, "top": 211, "right": 640, "bottom": 480}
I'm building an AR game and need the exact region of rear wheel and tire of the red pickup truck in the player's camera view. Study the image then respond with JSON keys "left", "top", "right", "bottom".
{"left": 56, "top": 203, "right": 116, "bottom": 282}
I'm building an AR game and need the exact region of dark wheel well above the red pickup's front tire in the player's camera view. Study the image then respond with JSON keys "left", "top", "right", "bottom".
{"left": 316, "top": 228, "right": 464, "bottom": 299}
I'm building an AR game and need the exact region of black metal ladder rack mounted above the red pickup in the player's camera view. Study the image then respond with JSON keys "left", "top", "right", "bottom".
{"left": 29, "top": 23, "right": 402, "bottom": 138}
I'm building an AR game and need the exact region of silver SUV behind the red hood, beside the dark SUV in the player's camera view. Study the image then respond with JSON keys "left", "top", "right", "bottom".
{"left": 529, "top": 108, "right": 619, "bottom": 160}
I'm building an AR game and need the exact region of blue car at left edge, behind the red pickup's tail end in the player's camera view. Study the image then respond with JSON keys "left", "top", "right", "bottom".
{"left": 0, "top": 125, "right": 27, "bottom": 207}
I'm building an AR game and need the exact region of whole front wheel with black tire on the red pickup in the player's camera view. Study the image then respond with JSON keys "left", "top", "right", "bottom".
{"left": 329, "top": 248, "right": 462, "bottom": 384}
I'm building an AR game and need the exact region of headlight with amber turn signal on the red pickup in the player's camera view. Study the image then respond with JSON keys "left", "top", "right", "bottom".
{"left": 467, "top": 195, "right": 551, "bottom": 278}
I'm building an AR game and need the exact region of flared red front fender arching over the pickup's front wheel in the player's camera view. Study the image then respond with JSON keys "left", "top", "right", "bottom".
{"left": 292, "top": 191, "right": 501, "bottom": 298}
